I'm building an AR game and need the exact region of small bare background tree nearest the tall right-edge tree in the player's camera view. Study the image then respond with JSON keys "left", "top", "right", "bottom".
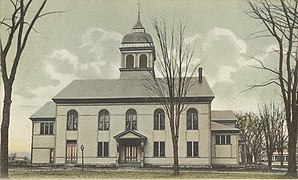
{"left": 258, "top": 103, "right": 284, "bottom": 170}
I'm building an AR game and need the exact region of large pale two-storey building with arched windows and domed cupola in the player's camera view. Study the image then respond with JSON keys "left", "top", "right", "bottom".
{"left": 30, "top": 14, "right": 239, "bottom": 167}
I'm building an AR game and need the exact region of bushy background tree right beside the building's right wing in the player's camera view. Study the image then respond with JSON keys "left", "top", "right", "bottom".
{"left": 237, "top": 113, "right": 262, "bottom": 165}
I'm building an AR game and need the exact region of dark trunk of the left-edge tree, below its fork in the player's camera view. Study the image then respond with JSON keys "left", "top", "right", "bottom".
{"left": 1, "top": 84, "right": 12, "bottom": 178}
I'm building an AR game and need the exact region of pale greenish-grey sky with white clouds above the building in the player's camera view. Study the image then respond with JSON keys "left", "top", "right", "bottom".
{"left": 0, "top": 0, "right": 280, "bottom": 155}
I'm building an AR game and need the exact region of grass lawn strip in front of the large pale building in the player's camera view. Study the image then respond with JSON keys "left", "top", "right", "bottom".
{"left": 9, "top": 167, "right": 289, "bottom": 179}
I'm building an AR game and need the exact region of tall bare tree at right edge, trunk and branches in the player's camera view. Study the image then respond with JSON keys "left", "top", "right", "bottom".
{"left": 247, "top": 0, "right": 298, "bottom": 176}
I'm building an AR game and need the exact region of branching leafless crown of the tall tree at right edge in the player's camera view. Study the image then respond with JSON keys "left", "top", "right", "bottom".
{"left": 247, "top": 0, "right": 298, "bottom": 91}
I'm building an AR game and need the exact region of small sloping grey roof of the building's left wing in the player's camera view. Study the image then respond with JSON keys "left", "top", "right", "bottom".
{"left": 29, "top": 101, "right": 56, "bottom": 120}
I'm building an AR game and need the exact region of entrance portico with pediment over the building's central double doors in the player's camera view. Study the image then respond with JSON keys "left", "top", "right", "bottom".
{"left": 114, "top": 130, "right": 147, "bottom": 167}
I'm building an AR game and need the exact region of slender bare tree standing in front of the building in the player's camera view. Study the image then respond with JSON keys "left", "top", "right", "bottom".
{"left": 145, "top": 19, "right": 199, "bottom": 175}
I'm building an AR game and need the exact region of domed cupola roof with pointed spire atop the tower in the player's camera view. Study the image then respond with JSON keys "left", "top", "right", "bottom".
{"left": 121, "top": 12, "right": 153, "bottom": 44}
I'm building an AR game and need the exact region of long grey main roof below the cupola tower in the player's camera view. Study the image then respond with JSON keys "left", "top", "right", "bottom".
{"left": 53, "top": 77, "right": 214, "bottom": 101}
